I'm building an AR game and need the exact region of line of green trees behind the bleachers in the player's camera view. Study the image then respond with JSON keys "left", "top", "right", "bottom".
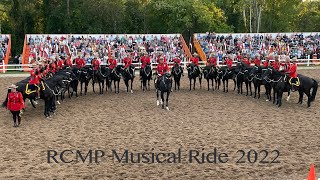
{"left": 0, "top": 0, "right": 320, "bottom": 55}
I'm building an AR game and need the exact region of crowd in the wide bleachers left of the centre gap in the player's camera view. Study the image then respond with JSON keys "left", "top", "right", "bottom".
{"left": 28, "top": 34, "right": 184, "bottom": 63}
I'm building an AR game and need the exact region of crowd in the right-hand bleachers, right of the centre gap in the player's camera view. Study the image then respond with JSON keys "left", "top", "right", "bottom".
{"left": 196, "top": 33, "right": 320, "bottom": 61}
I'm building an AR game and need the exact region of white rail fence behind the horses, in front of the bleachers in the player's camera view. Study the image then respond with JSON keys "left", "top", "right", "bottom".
{"left": 0, "top": 59, "right": 320, "bottom": 73}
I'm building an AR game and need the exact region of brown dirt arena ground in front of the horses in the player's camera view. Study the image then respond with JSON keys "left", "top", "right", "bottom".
{"left": 0, "top": 70, "right": 320, "bottom": 180}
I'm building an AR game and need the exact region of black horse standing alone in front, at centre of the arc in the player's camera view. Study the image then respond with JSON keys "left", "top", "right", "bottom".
{"left": 155, "top": 73, "right": 172, "bottom": 111}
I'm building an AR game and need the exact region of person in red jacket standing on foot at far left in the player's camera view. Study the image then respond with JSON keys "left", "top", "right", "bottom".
{"left": 6, "top": 84, "right": 25, "bottom": 127}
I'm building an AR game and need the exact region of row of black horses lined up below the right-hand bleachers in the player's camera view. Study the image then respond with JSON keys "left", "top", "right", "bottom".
{"left": 182, "top": 63, "right": 318, "bottom": 107}
